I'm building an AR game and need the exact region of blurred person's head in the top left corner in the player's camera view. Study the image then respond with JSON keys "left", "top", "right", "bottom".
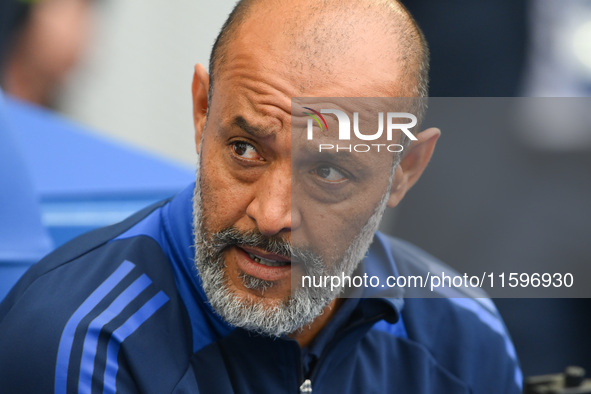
{"left": 0, "top": 0, "right": 91, "bottom": 107}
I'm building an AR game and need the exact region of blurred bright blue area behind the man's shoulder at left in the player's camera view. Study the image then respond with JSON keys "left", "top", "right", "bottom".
{"left": 0, "top": 93, "right": 194, "bottom": 299}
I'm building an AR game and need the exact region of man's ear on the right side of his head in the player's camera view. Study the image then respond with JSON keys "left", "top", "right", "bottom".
{"left": 388, "top": 127, "right": 441, "bottom": 207}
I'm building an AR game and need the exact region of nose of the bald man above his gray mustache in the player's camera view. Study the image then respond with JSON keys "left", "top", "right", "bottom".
{"left": 246, "top": 163, "right": 292, "bottom": 236}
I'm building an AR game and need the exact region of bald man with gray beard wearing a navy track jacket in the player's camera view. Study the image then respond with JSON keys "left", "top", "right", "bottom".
{"left": 0, "top": 0, "right": 521, "bottom": 394}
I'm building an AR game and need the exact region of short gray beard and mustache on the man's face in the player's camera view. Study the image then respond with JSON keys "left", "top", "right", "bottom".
{"left": 193, "top": 162, "right": 393, "bottom": 337}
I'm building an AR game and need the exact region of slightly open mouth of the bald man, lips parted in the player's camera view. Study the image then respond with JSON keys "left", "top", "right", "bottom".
{"left": 235, "top": 246, "right": 291, "bottom": 281}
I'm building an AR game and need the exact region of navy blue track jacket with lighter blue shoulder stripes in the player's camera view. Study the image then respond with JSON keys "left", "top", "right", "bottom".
{"left": 0, "top": 185, "right": 521, "bottom": 394}
